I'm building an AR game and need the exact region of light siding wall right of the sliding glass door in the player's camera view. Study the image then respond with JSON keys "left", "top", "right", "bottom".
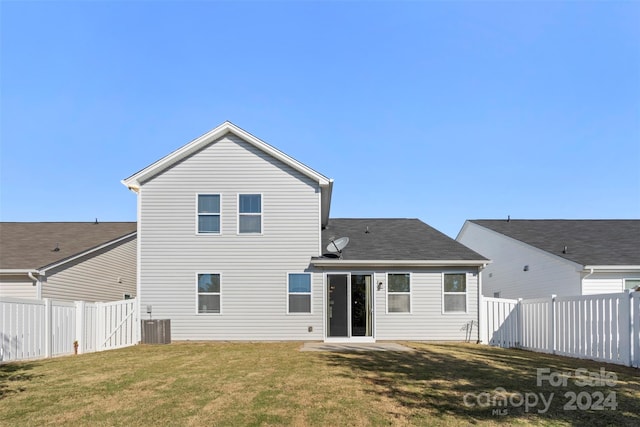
{"left": 374, "top": 268, "right": 478, "bottom": 342}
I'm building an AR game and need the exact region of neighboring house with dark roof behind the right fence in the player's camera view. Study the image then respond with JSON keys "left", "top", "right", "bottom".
{"left": 457, "top": 219, "right": 640, "bottom": 298}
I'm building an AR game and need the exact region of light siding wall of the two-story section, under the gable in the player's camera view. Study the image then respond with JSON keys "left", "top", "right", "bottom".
{"left": 138, "top": 134, "right": 323, "bottom": 340}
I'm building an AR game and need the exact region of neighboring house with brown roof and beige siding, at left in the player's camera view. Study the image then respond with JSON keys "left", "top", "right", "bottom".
{"left": 0, "top": 221, "right": 137, "bottom": 302}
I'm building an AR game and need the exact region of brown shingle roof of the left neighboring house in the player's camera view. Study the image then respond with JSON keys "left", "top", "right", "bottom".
{"left": 0, "top": 222, "right": 137, "bottom": 270}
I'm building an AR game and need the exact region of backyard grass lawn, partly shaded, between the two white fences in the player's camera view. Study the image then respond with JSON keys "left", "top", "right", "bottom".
{"left": 0, "top": 343, "right": 640, "bottom": 426}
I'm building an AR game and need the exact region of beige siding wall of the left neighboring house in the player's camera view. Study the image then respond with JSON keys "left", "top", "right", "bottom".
{"left": 42, "top": 237, "right": 136, "bottom": 302}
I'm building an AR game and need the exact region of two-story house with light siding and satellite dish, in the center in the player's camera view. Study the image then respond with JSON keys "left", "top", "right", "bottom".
{"left": 123, "top": 122, "right": 488, "bottom": 341}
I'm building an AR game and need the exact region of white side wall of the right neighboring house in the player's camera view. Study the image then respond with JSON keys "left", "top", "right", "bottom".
{"left": 457, "top": 221, "right": 582, "bottom": 298}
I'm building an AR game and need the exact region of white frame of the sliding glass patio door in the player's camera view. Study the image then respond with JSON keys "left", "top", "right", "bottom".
{"left": 322, "top": 271, "right": 376, "bottom": 343}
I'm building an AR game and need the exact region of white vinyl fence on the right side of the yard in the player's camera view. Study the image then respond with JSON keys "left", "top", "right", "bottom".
{"left": 480, "top": 291, "right": 640, "bottom": 367}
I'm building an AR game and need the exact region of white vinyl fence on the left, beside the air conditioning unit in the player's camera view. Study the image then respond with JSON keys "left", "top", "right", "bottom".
{"left": 0, "top": 298, "right": 139, "bottom": 362}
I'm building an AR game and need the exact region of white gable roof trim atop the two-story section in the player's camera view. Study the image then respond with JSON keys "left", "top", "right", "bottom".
{"left": 122, "top": 121, "right": 333, "bottom": 226}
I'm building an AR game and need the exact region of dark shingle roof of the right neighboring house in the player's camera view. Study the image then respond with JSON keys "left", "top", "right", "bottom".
{"left": 470, "top": 219, "right": 640, "bottom": 265}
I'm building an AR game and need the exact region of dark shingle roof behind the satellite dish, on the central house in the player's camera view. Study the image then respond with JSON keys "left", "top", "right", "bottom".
{"left": 322, "top": 218, "right": 486, "bottom": 261}
